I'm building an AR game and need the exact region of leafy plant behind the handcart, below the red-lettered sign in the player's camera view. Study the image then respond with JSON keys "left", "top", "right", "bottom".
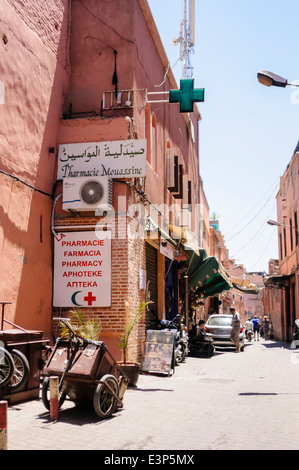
{"left": 59, "top": 310, "right": 102, "bottom": 341}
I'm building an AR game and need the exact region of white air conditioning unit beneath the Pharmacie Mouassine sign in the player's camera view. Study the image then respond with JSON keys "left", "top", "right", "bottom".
{"left": 62, "top": 177, "right": 112, "bottom": 215}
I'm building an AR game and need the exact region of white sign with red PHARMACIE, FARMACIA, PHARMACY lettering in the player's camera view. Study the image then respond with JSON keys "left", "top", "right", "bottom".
{"left": 53, "top": 231, "right": 111, "bottom": 307}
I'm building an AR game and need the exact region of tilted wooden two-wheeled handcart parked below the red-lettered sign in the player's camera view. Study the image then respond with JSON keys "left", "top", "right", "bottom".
{"left": 42, "top": 318, "right": 129, "bottom": 419}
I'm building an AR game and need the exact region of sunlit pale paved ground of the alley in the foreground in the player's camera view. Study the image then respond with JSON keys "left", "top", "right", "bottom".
{"left": 7, "top": 340, "right": 299, "bottom": 454}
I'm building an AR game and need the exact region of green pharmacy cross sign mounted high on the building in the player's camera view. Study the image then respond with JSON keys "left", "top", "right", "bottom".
{"left": 169, "top": 78, "right": 205, "bottom": 113}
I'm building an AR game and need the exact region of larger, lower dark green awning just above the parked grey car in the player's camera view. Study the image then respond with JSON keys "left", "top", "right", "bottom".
{"left": 188, "top": 250, "right": 233, "bottom": 299}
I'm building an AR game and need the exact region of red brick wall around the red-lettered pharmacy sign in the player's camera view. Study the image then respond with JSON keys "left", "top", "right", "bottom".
{"left": 53, "top": 217, "right": 145, "bottom": 360}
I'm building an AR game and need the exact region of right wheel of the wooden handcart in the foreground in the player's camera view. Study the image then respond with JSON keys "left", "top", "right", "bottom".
{"left": 93, "top": 374, "right": 119, "bottom": 418}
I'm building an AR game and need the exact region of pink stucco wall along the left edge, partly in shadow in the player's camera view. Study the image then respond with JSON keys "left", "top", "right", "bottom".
{"left": 0, "top": 0, "right": 69, "bottom": 331}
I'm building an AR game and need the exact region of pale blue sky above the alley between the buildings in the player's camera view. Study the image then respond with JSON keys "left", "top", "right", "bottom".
{"left": 148, "top": 0, "right": 299, "bottom": 272}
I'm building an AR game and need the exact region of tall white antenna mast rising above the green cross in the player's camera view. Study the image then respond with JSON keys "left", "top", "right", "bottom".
{"left": 171, "top": 0, "right": 195, "bottom": 78}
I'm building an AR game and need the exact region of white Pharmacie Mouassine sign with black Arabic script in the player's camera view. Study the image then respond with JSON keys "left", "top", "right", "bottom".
{"left": 57, "top": 139, "right": 147, "bottom": 179}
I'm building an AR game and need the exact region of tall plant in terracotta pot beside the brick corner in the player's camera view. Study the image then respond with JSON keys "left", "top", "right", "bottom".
{"left": 119, "top": 302, "right": 151, "bottom": 386}
